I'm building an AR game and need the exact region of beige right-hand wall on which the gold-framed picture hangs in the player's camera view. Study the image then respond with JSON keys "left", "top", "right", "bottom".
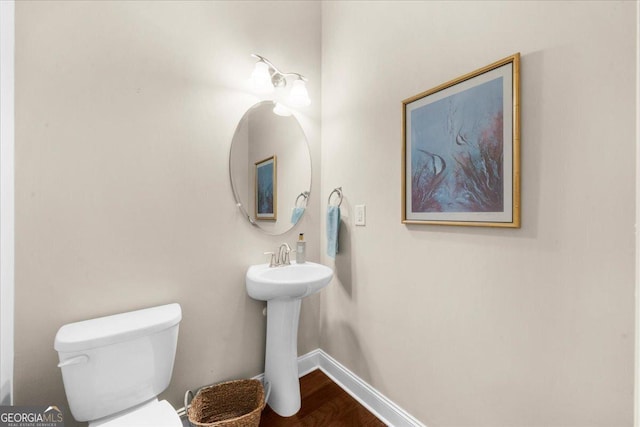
{"left": 321, "top": 1, "right": 637, "bottom": 427}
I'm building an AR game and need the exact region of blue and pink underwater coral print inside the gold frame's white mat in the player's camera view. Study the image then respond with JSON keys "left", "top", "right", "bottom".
{"left": 411, "top": 77, "right": 504, "bottom": 212}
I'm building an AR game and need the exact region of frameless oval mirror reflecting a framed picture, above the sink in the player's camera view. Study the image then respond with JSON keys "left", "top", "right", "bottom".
{"left": 229, "top": 101, "right": 311, "bottom": 234}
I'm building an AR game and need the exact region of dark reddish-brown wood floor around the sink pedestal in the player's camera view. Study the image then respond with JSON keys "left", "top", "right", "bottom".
{"left": 260, "top": 370, "right": 385, "bottom": 427}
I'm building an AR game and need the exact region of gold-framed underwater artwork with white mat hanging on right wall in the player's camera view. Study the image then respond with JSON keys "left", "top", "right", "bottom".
{"left": 402, "top": 53, "right": 520, "bottom": 228}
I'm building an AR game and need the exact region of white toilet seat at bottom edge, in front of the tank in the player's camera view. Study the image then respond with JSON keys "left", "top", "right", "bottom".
{"left": 89, "top": 399, "right": 182, "bottom": 427}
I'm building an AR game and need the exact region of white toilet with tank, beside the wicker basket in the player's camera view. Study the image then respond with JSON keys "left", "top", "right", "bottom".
{"left": 54, "top": 304, "right": 182, "bottom": 427}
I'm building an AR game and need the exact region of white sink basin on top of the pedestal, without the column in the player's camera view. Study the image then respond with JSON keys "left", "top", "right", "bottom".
{"left": 246, "top": 261, "right": 333, "bottom": 301}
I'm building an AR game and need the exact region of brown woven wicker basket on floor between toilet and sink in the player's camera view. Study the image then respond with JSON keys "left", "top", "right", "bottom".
{"left": 187, "top": 380, "right": 265, "bottom": 427}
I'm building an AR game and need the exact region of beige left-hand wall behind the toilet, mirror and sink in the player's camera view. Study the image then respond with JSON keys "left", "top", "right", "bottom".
{"left": 15, "top": 1, "right": 321, "bottom": 425}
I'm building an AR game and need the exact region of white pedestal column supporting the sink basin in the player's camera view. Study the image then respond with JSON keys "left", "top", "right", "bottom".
{"left": 264, "top": 298, "right": 302, "bottom": 417}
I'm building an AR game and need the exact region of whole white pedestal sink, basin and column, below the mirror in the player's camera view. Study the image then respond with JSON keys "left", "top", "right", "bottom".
{"left": 246, "top": 262, "right": 333, "bottom": 417}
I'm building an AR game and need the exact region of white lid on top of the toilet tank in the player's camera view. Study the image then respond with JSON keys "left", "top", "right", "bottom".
{"left": 54, "top": 303, "right": 182, "bottom": 352}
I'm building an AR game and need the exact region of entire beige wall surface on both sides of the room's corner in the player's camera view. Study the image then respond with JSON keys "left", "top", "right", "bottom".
{"left": 15, "top": 1, "right": 637, "bottom": 427}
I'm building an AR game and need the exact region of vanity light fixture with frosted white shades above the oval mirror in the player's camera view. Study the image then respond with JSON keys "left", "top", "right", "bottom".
{"left": 250, "top": 53, "right": 311, "bottom": 108}
